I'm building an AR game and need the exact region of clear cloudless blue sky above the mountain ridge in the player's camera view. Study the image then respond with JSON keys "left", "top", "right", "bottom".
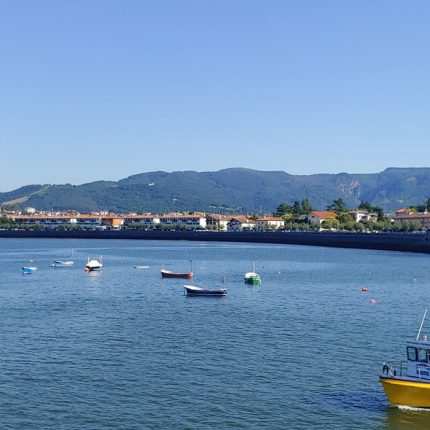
{"left": 0, "top": 0, "right": 430, "bottom": 192}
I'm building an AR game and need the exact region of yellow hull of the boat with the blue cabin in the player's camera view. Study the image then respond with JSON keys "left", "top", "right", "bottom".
{"left": 380, "top": 377, "right": 430, "bottom": 408}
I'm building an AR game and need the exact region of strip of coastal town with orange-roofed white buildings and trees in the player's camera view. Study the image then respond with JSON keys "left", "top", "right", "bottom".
{"left": 0, "top": 207, "right": 430, "bottom": 232}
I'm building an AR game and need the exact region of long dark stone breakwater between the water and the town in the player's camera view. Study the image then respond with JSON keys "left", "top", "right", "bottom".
{"left": 0, "top": 230, "right": 430, "bottom": 253}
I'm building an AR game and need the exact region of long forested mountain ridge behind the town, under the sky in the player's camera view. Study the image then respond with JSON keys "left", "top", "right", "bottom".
{"left": 0, "top": 168, "right": 430, "bottom": 214}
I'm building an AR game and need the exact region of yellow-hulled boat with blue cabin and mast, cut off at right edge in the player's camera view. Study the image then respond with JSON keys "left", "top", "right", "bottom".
{"left": 379, "top": 309, "right": 430, "bottom": 408}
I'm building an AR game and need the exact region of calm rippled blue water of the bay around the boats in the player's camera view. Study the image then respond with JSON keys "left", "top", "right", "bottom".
{"left": 0, "top": 239, "right": 430, "bottom": 430}
